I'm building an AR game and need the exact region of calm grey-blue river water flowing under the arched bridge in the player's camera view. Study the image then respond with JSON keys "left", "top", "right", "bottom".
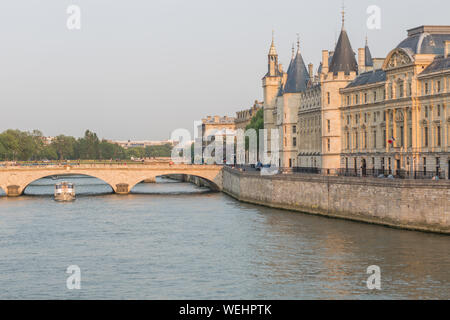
{"left": 0, "top": 177, "right": 450, "bottom": 299}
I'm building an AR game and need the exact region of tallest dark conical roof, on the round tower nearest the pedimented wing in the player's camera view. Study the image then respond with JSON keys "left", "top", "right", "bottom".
{"left": 329, "top": 29, "right": 358, "bottom": 74}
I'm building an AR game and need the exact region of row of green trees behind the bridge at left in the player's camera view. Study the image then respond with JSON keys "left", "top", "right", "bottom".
{"left": 0, "top": 129, "right": 172, "bottom": 161}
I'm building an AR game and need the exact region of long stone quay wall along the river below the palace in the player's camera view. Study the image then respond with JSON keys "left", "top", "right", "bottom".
{"left": 222, "top": 167, "right": 450, "bottom": 234}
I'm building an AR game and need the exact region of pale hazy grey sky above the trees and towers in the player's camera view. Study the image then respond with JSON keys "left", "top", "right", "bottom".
{"left": 0, "top": 0, "right": 450, "bottom": 139}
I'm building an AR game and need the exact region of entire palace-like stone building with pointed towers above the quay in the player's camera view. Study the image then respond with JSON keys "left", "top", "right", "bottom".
{"left": 263, "top": 19, "right": 450, "bottom": 179}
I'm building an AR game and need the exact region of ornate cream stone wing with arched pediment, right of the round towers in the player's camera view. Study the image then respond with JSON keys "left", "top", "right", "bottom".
{"left": 340, "top": 26, "right": 450, "bottom": 178}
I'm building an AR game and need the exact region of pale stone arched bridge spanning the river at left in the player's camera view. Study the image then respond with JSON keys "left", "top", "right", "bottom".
{"left": 0, "top": 163, "right": 223, "bottom": 197}
